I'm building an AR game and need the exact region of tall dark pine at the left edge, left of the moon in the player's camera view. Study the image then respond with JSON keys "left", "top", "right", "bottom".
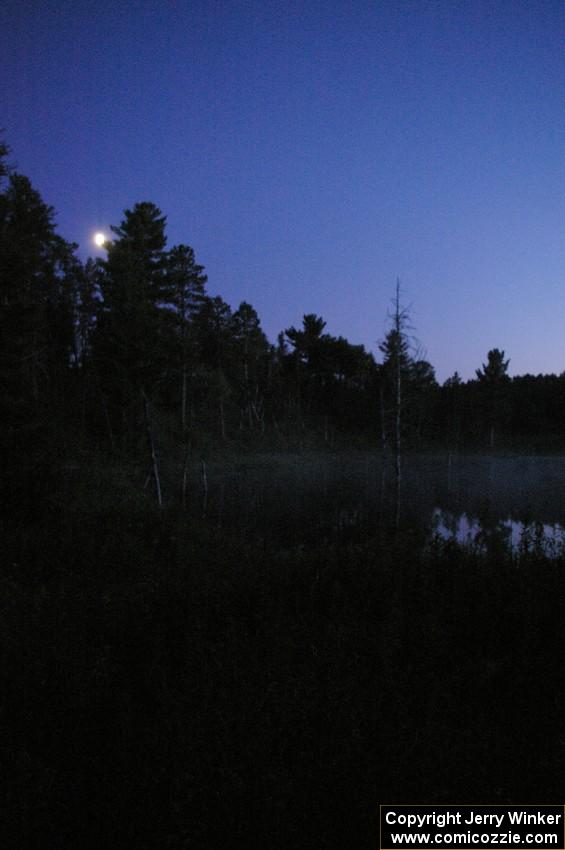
{"left": 0, "top": 164, "right": 79, "bottom": 510}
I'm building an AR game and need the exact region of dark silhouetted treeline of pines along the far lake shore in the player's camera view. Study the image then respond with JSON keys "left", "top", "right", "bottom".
{"left": 0, "top": 138, "right": 565, "bottom": 496}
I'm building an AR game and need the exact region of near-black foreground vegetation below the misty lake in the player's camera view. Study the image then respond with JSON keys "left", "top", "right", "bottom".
{"left": 1, "top": 476, "right": 565, "bottom": 850}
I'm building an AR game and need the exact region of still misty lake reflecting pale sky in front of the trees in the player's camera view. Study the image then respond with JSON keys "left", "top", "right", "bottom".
{"left": 190, "top": 453, "right": 565, "bottom": 549}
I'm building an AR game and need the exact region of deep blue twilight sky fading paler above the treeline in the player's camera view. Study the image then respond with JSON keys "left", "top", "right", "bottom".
{"left": 0, "top": 0, "right": 565, "bottom": 381}
